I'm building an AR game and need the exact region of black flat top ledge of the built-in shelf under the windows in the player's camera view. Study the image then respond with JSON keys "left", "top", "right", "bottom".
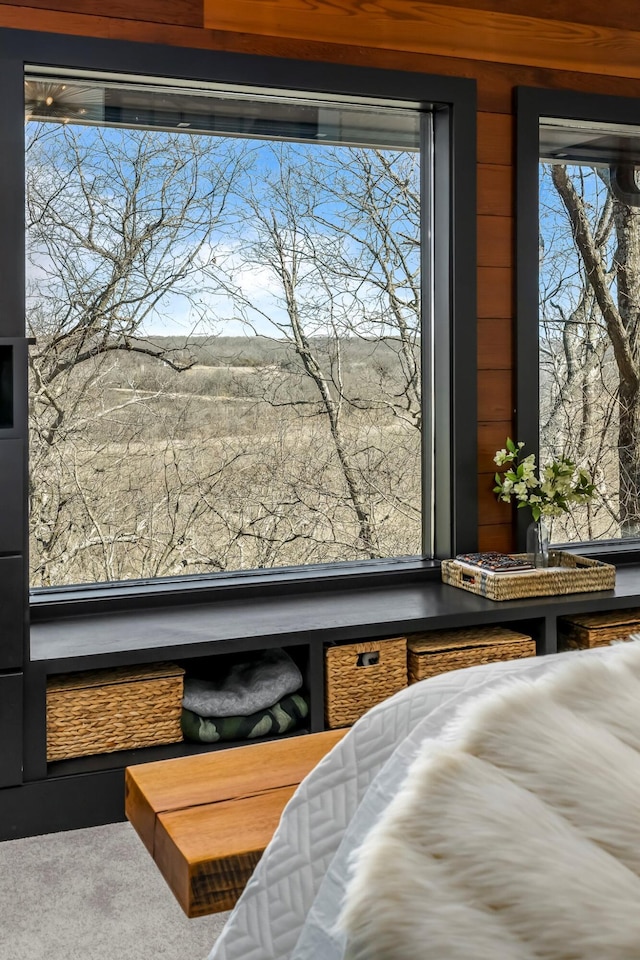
{"left": 31, "top": 565, "right": 640, "bottom": 673}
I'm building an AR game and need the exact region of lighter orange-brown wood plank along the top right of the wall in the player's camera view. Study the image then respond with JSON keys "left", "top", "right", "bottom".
{"left": 204, "top": 0, "right": 640, "bottom": 77}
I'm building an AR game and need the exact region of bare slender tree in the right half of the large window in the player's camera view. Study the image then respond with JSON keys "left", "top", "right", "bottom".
{"left": 218, "top": 145, "right": 421, "bottom": 558}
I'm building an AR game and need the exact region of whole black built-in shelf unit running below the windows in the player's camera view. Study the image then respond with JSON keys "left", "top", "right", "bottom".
{"left": 5, "top": 565, "right": 640, "bottom": 839}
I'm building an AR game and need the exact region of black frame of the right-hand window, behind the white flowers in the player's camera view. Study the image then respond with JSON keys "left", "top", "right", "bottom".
{"left": 515, "top": 87, "right": 640, "bottom": 563}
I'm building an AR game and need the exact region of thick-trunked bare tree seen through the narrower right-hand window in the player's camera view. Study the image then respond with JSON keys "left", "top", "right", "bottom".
{"left": 551, "top": 164, "right": 640, "bottom": 537}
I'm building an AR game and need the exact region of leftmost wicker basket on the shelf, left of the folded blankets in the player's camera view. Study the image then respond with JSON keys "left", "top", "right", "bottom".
{"left": 47, "top": 663, "right": 184, "bottom": 760}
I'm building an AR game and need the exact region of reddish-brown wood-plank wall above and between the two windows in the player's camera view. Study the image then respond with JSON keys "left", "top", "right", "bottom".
{"left": 0, "top": 0, "right": 640, "bottom": 550}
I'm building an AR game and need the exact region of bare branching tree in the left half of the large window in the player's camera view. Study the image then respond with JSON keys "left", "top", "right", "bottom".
{"left": 27, "top": 123, "right": 242, "bottom": 583}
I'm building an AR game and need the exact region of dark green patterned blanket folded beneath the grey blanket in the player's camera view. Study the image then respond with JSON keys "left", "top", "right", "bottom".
{"left": 182, "top": 693, "right": 309, "bottom": 743}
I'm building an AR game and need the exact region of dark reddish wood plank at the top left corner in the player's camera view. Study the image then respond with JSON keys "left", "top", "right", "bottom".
{"left": 0, "top": 0, "right": 204, "bottom": 27}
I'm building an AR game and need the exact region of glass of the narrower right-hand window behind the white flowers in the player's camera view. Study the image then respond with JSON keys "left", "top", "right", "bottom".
{"left": 539, "top": 119, "right": 640, "bottom": 542}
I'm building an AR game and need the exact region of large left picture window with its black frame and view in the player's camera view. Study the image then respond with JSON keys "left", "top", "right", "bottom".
{"left": 0, "top": 33, "right": 477, "bottom": 612}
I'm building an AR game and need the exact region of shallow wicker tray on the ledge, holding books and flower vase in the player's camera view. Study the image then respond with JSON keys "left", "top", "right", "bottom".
{"left": 441, "top": 550, "right": 616, "bottom": 600}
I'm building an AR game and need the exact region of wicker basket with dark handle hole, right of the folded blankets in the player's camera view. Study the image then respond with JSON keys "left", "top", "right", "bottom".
{"left": 325, "top": 637, "right": 407, "bottom": 728}
